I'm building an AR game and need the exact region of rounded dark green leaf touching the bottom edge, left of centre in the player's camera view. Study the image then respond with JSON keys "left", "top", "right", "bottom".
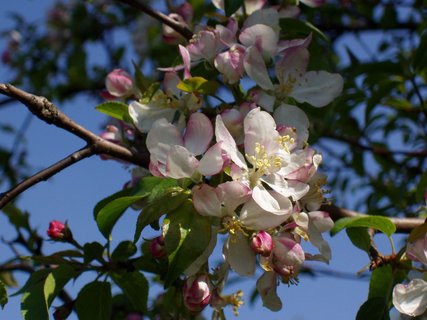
{"left": 75, "top": 281, "right": 112, "bottom": 320}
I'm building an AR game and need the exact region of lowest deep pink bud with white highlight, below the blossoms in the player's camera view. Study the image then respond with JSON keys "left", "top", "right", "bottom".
{"left": 182, "top": 274, "right": 211, "bottom": 313}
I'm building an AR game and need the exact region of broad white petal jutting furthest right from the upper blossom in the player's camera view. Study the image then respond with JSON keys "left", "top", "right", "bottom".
{"left": 289, "top": 71, "right": 344, "bottom": 107}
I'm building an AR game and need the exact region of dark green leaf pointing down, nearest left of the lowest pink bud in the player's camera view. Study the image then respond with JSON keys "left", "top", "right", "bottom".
{"left": 111, "top": 271, "right": 148, "bottom": 313}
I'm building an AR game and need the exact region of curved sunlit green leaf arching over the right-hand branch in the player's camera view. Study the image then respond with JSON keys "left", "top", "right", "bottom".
{"left": 331, "top": 215, "right": 396, "bottom": 237}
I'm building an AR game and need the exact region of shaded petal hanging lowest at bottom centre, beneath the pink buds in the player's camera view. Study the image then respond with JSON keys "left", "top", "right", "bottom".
{"left": 256, "top": 271, "right": 282, "bottom": 311}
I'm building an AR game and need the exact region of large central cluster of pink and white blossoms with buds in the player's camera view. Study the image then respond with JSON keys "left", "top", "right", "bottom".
{"left": 98, "top": 1, "right": 343, "bottom": 312}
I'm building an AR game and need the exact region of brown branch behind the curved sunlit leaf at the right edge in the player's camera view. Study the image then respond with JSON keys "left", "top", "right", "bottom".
{"left": 321, "top": 205, "right": 424, "bottom": 233}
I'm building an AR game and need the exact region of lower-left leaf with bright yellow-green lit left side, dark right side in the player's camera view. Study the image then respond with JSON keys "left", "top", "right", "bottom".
{"left": 43, "top": 264, "right": 78, "bottom": 308}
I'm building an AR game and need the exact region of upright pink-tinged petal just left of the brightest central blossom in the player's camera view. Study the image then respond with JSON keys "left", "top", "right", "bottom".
{"left": 184, "top": 112, "right": 213, "bottom": 156}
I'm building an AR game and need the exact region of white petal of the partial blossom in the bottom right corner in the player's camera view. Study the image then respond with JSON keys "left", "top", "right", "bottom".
{"left": 393, "top": 279, "right": 427, "bottom": 317}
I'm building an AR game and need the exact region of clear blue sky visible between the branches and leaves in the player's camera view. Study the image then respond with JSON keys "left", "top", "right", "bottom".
{"left": 0, "top": 0, "right": 408, "bottom": 320}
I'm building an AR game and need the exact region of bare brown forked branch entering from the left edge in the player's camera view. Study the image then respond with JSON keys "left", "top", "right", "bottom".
{"left": 0, "top": 84, "right": 148, "bottom": 209}
